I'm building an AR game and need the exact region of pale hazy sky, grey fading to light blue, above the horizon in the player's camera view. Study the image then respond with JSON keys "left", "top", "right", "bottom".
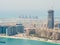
{"left": 0, "top": 0, "right": 60, "bottom": 19}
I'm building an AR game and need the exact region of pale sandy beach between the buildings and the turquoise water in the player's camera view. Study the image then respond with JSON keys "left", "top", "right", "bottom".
{"left": 0, "top": 34, "right": 60, "bottom": 44}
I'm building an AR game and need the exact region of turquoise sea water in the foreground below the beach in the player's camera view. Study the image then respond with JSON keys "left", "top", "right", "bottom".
{"left": 0, "top": 38, "right": 60, "bottom": 45}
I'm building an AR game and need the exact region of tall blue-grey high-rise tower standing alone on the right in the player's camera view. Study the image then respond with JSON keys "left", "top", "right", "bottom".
{"left": 48, "top": 10, "right": 54, "bottom": 29}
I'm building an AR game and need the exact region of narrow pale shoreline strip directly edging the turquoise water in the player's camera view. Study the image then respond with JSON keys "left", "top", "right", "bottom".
{"left": 0, "top": 36, "right": 60, "bottom": 44}
